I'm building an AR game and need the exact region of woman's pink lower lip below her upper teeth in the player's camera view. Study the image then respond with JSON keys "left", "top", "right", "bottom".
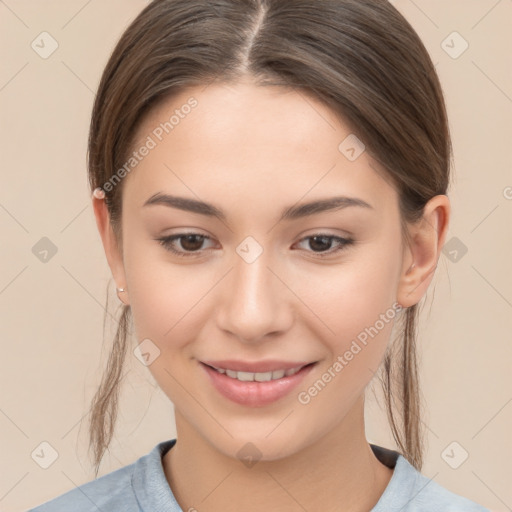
{"left": 201, "top": 363, "right": 316, "bottom": 407}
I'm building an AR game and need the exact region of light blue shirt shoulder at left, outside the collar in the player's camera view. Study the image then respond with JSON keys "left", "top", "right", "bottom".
{"left": 27, "top": 464, "right": 139, "bottom": 512}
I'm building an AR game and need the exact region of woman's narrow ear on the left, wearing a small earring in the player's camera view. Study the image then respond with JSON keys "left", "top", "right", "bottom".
{"left": 92, "top": 189, "right": 129, "bottom": 305}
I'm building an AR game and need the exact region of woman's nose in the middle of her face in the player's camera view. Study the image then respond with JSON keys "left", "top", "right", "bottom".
{"left": 217, "top": 245, "right": 294, "bottom": 343}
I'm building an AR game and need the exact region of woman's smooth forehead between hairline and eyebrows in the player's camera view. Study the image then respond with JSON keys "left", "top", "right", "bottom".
{"left": 123, "top": 82, "right": 396, "bottom": 214}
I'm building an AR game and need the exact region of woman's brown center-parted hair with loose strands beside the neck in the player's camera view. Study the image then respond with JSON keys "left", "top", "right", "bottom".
{"left": 88, "top": 0, "right": 452, "bottom": 475}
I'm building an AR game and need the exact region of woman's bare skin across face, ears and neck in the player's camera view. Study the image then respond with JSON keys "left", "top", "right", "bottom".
{"left": 93, "top": 81, "right": 450, "bottom": 512}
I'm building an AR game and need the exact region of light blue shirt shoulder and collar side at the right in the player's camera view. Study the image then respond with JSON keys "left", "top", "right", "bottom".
{"left": 372, "top": 455, "right": 489, "bottom": 512}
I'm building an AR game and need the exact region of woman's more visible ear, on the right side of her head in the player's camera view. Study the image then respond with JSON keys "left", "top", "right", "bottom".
{"left": 397, "top": 195, "right": 451, "bottom": 308}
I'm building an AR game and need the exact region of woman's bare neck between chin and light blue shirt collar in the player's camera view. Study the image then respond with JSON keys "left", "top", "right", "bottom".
{"left": 163, "top": 398, "right": 393, "bottom": 512}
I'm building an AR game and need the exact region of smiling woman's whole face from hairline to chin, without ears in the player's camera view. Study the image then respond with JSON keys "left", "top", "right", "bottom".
{"left": 98, "top": 83, "right": 410, "bottom": 460}
